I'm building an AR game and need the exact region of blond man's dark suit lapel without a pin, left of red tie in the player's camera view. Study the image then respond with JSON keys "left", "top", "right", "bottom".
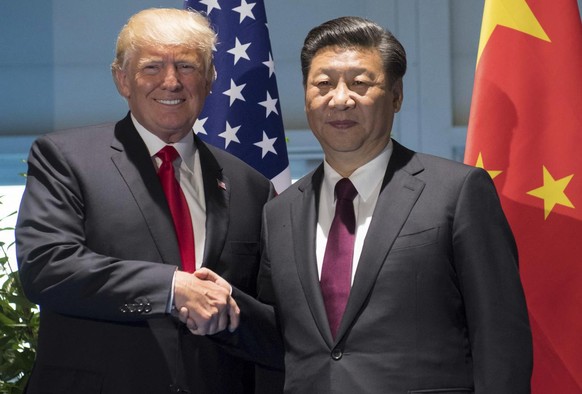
{"left": 111, "top": 115, "right": 180, "bottom": 266}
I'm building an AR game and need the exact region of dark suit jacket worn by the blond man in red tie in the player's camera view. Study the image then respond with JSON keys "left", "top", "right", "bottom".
{"left": 16, "top": 115, "right": 274, "bottom": 394}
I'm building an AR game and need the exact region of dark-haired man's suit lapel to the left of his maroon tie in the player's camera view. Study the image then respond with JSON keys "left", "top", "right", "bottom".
{"left": 290, "top": 166, "right": 333, "bottom": 347}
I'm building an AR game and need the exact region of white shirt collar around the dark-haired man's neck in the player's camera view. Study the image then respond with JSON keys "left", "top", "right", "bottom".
{"left": 323, "top": 140, "right": 394, "bottom": 201}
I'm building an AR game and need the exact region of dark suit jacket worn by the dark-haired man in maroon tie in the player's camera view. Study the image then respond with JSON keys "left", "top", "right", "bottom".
{"left": 234, "top": 142, "right": 532, "bottom": 394}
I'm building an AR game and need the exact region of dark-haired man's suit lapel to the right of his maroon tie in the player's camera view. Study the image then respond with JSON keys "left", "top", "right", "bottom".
{"left": 338, "top": 141, "right": 425, "bottom": 339}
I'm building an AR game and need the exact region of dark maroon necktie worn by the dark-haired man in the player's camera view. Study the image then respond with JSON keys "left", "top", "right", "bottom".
{"left": 320, "top": 178, "right": 358, "bottom": 338}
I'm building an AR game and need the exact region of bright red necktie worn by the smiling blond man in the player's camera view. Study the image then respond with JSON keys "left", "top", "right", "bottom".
{"left": 156, "top": 145, "right": 196, "bottom": 272}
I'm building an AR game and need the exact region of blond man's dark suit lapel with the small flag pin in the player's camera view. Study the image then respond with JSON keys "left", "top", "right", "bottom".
{"left": 194, "top": 136, "right": 230, "bottom": 266}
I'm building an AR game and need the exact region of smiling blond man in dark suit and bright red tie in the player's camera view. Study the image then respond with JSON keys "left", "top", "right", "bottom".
{"left": 16, "top": 9, "right": 274, "bottom": 394}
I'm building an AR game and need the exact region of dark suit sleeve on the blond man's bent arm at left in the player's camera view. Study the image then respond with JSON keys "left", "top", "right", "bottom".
{"left": 16, "top": 137, "right": 175, "bottom": 321}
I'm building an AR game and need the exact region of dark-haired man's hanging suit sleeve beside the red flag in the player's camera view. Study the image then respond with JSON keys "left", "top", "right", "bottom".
{"left": 453, "top": 169, "right": 532, "bottom": 394}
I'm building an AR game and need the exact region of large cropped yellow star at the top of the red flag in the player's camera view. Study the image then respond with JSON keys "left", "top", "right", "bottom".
{"left": 477, "top": 0, "right": 550, "bottom": 64}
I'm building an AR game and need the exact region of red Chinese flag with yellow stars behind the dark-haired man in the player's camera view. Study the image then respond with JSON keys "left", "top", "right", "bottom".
{"left": 465, "top": 0, "right": 582, "bottom": 394}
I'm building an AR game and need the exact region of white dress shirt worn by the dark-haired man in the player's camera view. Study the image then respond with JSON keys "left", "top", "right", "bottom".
{"left": 316, "top": 140, "right": 392, "bottom": 285}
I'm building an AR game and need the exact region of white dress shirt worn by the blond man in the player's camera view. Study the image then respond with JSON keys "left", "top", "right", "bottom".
{"left": 131, "top": 114, "right": 206, "bottom": 269}
